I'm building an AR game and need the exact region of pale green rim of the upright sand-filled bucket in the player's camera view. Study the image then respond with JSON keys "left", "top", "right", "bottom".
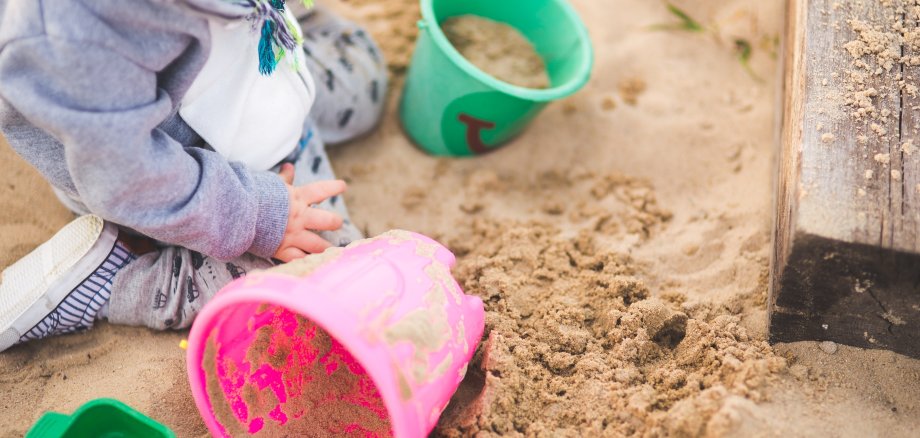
{"left": 419, "top": 0, "right": 594, "bottom": 102}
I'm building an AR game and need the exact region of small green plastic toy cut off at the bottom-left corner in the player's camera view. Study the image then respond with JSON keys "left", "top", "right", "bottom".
{"left": 26, "top": 398, "right": 176, "bottom": 438}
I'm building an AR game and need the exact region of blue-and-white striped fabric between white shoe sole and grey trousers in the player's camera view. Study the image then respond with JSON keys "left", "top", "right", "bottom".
{"left": 19, "top": 242, "right": 135, "bottom": 343}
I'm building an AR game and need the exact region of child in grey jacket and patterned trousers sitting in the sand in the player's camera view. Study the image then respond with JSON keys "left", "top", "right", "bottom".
{"left": 0, "top": 0, "right": 386, "bottom": 351}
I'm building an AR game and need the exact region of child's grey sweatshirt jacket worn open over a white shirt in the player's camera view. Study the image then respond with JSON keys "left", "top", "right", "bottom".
{"left": 0, "top": 0, "right": 288, "bottom": 260}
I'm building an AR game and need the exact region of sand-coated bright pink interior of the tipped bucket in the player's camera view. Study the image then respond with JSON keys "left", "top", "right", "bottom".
{"left": 202, "top": 306, "right": 392, "bottom": 437}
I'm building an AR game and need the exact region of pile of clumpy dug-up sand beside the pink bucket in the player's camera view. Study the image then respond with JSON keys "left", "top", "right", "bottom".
{"left": 437, "top": 220, "right": 786, "bottom": 436}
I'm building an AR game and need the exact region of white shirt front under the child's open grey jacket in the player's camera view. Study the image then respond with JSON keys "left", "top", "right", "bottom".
{"left": 179, "top": 10, "right": 316, "bottom": 170}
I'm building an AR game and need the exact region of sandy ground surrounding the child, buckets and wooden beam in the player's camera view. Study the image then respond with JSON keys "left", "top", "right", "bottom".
{"left": 0, "top": 0, "right": 920, "bottom": 437}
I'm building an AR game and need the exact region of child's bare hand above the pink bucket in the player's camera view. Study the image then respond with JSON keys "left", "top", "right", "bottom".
{"left": 273, "top": 163, "right": 346, "bottom": 262}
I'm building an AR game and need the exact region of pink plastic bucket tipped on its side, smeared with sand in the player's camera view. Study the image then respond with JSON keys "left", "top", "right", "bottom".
{"left": 187, "top": 231, "right": 484, "bottom": 437}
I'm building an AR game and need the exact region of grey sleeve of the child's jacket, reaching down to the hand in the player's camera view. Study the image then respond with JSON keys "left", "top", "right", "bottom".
{"left": 0, "top": 36, "right": 288, "bottom": 260}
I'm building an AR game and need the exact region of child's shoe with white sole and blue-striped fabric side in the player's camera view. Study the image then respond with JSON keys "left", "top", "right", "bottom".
{"left": 0, "top": 215, "right": 134, "bottom": 351}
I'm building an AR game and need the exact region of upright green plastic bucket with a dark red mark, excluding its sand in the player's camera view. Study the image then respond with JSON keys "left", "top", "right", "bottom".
{"left": 399, "top": 0, "right": 593, "bottom": 156}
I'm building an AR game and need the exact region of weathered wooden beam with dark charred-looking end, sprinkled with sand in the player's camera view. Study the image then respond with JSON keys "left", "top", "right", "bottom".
{"left": 769, "top": 0, "right": 920, "bottom": 357}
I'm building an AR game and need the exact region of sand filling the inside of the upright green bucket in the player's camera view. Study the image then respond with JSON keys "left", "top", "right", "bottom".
{"left": 441, "top": 15, "right": 550, "bottom": 88}
